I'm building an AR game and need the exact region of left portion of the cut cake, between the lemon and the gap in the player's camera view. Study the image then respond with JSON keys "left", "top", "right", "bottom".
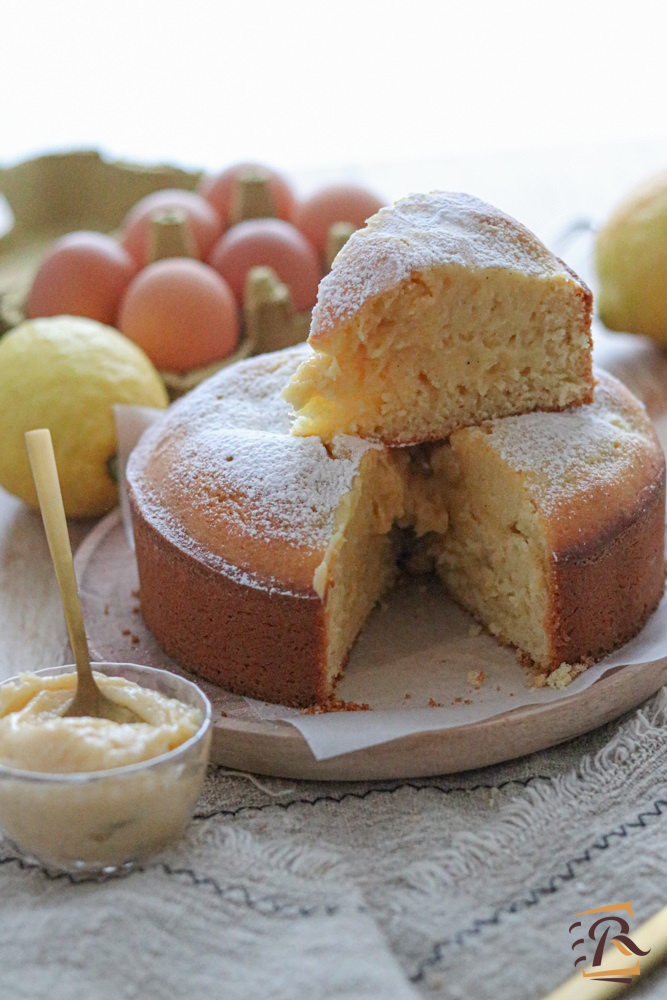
{"left": 127, "top": 348, "right": 403, "bottom": 705}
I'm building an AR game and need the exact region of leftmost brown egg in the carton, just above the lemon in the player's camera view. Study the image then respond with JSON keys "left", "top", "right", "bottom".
{"left": 26, "top": 231, "right": 136, "bottom": 326}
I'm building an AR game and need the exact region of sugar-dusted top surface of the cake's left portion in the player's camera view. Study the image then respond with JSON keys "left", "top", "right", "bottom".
{"left": 128, "top": 345, "right": 374, "bottom": 576}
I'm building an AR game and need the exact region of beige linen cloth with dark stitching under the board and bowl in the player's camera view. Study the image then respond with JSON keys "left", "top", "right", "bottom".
{"left": 0, "top": 689, "right": 667, "bottom": 1000}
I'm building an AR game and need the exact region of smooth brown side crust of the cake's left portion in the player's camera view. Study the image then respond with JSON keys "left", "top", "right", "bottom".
{"left": 130, "top": 508, "right": 330, "bottom": 705}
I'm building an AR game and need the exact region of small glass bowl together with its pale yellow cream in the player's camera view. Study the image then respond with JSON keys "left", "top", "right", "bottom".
{"left": 0, "top": 663, "right": 211, "bottom": 874}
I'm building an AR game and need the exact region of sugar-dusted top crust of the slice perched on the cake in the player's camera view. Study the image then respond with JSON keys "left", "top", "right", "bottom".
{"left": 311, "top": 191, "right": 576, "bottom": 341}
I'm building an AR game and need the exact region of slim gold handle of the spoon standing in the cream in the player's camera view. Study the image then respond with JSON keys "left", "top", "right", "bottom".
{"left": 25, "top": 428, "right": 95, "bottom": 689}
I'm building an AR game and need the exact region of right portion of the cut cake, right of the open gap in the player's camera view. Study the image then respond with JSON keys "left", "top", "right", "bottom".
{"left": 429, "top": 370, "right": 665, "bottom": 677}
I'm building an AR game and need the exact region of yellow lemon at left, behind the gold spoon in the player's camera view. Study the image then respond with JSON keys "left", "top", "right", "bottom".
{"left": 0, "top": 316, "right": 168, "bottom": 517}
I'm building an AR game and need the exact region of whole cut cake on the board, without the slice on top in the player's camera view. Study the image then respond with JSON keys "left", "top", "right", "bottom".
{"left": 127, "top": 345, "right": 665, "bottom": 705}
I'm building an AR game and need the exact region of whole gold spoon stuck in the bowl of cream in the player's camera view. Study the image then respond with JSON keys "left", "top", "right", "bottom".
{"left": 25, "top": 429, "right": 143, "bottom": 722}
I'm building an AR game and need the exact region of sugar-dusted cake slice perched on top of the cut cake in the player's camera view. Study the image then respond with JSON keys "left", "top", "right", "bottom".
{"left": 285, "top": 192, "right": 593, "bottom": 446}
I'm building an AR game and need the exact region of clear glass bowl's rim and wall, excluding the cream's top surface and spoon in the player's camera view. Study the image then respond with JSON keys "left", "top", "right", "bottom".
{"left": 0, "top": 663, "right": 211, "bottom": 875}
